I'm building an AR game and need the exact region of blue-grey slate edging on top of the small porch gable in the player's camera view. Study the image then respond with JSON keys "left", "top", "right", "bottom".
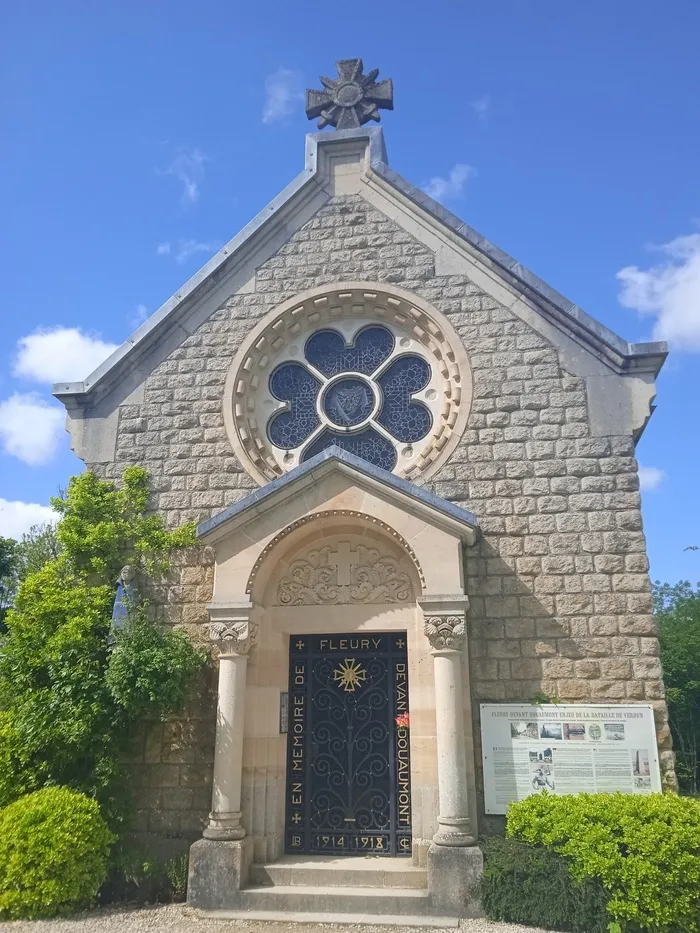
{"left": 197, "top": 445, "right": 479, "bottom": 538}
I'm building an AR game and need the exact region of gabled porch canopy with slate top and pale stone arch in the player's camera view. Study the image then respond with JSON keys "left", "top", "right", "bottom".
{"left": 197, "top": 447, "right": 478, "bottom": 608}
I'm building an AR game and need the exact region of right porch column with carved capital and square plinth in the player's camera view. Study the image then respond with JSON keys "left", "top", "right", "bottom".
{"left": 419, "top": 594, "right": 483, "bottom": 916}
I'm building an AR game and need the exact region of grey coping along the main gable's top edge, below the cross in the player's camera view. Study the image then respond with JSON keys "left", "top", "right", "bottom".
{"left": 52, "top": 126, "right": 668, "bottom": 404}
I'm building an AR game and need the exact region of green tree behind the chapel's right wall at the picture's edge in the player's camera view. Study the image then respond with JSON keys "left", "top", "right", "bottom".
{"left": 654, "top": 580, "right": 700, "bottom": 794}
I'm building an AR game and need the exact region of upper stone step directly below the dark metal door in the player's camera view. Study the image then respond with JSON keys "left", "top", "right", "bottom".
{"left": 250, "top": 855, "right": 428, "bottom": 889}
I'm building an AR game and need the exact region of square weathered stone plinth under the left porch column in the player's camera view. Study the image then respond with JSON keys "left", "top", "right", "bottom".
{"left": 187, "top": 839, "right": 253, "bottom": 910}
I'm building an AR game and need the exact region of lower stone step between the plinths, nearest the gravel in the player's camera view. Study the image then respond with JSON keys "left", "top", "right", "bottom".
{"left": 236, "top": 885, "right": 437, "bottom": 923}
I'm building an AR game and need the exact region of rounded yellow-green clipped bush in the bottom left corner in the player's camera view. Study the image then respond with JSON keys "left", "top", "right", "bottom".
{"left": 0, "top": 787, "right": 115, "bottom": 920}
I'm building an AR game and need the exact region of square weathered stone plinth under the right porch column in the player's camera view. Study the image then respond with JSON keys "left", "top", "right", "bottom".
{"left": 428, "top": 842, "right": 484, "bottom": 917}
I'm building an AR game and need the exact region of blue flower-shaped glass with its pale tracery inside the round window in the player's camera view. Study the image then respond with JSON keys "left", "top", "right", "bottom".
{"left": 267, "top": 324, "right": 435, "bottom": 470}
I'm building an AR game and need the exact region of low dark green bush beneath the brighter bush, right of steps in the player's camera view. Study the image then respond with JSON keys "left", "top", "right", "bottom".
{"left": 480, "top": 836, "right": 610, "bottom": 933}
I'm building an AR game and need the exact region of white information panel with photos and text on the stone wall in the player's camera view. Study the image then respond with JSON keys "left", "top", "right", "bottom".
{"left": 481, "top": 703, "right": 661, "bottom": 813}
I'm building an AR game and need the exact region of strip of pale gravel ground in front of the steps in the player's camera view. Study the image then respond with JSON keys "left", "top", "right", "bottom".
{"left": 0, "top": 904, "right": 556, "bottom": 933}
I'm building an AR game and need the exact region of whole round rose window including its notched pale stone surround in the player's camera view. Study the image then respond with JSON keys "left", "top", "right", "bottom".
{"left": 224, "top": 283, "right": 471, "bottom": 483}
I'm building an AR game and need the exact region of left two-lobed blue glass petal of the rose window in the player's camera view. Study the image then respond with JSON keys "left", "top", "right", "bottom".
{"left": 267, "top": 363, "right": 321, "bottom": 450}
